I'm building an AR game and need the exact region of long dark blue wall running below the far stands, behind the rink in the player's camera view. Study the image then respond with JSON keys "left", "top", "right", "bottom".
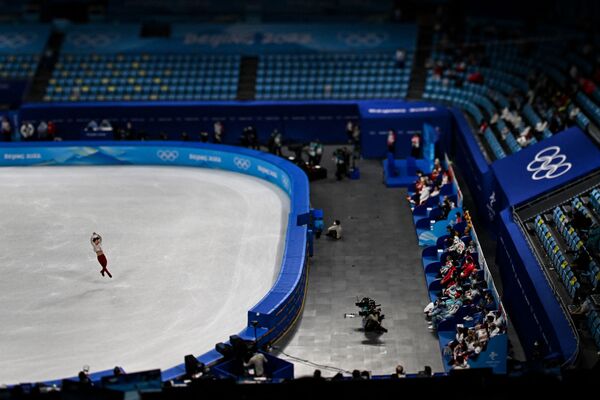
{"left": 19, "top": 101, "right": 358, "bottom": 144}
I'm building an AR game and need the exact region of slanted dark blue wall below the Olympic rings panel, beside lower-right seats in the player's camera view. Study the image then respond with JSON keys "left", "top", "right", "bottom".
{"left": 496, "top": 209, "right": 578, "bottom": 361}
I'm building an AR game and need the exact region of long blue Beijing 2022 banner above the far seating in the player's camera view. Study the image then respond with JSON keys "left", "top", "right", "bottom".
{"left": 62, "top": 23, "right": 417, "bottom": 56}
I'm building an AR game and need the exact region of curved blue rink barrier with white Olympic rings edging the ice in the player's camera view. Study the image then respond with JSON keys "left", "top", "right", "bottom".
{"left": 0, "top": 141, "right": 309, "bottom": 382}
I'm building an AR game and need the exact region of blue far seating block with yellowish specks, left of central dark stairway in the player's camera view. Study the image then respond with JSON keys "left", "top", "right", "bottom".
{"left": 44, "top": 54, "right": 240, "bottom": 102}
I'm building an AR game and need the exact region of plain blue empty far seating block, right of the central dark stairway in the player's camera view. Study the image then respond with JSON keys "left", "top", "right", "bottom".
{"left": 256, "top": 53, "right": 412, "bottom": 100}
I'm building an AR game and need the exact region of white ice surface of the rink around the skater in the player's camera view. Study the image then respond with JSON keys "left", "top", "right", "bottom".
{"left": 0, "top": 166, "right": 290, "bottom": 384}
